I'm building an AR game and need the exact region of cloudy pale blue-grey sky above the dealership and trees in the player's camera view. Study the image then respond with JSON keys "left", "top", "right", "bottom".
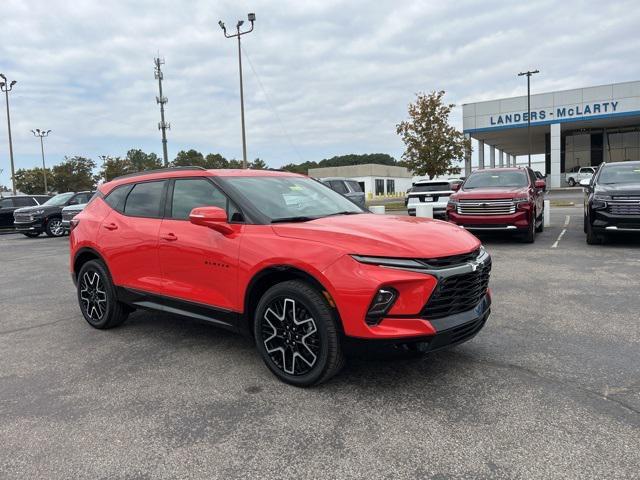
{"left": 0, "top": 0, "right": 640, "bottom": 185}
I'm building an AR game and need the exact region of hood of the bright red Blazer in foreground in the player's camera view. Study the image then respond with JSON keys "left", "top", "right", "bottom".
{"left": 273, "top": 214, "right": 480, "bottom": 258}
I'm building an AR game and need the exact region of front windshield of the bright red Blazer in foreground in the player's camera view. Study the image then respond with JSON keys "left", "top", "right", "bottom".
{"left": 224, "top": 176, "right": 363, "bottom": 222}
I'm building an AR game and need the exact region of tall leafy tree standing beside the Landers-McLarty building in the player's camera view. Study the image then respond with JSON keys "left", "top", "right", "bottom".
{"left": 396, "top": 90, "right": 464, "bottom": 178}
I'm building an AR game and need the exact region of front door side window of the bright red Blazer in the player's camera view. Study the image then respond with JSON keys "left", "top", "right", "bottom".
{"left": 171, "top": 178, "right": 227, "bottom": 220}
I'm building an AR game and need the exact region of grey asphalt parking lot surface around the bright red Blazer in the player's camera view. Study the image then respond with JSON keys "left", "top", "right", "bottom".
{"left": 0, "top": 207, "right": 640, "bottom": 479}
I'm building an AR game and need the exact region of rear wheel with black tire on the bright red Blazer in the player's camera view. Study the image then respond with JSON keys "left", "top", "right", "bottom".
{"left": 77, "top": 260, "right": 130, "bottom": 330}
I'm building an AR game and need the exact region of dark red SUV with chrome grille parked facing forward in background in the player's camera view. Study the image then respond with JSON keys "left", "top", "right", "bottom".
{"left": 447, "top": 167, "right": 546, "bottom": 243}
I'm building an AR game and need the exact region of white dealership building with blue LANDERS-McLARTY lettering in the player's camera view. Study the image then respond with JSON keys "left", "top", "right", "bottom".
{"left": 462, "top": 81, "right": 640, "bottom": 187}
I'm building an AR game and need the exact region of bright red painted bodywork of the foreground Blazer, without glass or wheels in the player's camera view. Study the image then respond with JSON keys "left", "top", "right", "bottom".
{"left": 70, "top": 170, "right": 490, "bottom": 338}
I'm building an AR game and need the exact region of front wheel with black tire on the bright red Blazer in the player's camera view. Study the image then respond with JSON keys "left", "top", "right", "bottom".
{"left": 253, "top": 280, "right": 344, "bottom": 387}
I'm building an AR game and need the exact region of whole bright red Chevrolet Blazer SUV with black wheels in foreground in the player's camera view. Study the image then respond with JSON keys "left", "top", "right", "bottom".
{"left": 70, "top": 167, "right": 491, "bottom": 386}
